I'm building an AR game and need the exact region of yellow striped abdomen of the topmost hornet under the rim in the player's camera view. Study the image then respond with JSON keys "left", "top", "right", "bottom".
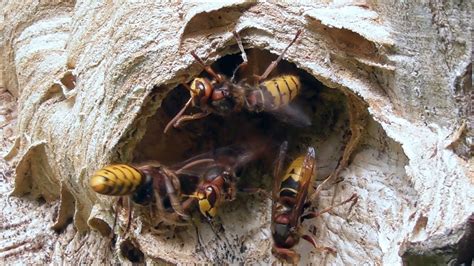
{"left": 260, "top": 75, "right": 301, "bottom": 111}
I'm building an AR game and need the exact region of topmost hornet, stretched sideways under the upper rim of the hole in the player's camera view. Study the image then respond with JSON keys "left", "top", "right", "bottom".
{"left": 164, "top": 30, "right": 311, "bottom": 133}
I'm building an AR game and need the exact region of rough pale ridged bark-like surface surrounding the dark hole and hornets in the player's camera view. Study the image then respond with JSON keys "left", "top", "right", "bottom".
{"left": 0, "top": 1, "right": 474, "bottom": 265}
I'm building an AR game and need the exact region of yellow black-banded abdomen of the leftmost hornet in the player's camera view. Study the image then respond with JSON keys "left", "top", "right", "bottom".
{"left": 89, "top": 164, "right": 144, "bottom": 196}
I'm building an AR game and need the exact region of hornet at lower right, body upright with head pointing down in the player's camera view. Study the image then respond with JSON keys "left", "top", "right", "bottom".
{"left": 271, "top": 142, "right": 357, "bottom": 264}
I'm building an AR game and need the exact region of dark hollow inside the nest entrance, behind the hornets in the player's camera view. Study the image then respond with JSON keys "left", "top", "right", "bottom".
{"left": 134, "top": 49, "right": 349, "bottom": 195}
